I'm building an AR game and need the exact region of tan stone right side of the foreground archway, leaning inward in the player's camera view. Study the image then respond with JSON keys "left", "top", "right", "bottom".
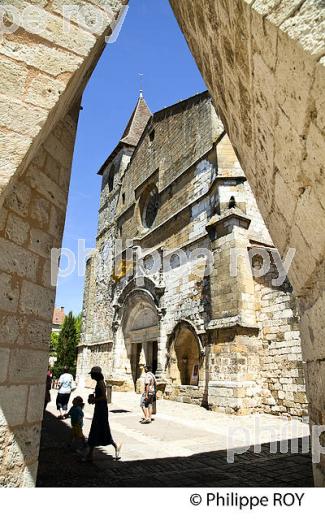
{"left": 170, "top": 0, "right": 325, "bottom": 485}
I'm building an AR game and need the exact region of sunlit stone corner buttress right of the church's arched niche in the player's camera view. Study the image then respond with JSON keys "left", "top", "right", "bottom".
{"left": 207, "top": 208, "right": 260, "bottom": 413}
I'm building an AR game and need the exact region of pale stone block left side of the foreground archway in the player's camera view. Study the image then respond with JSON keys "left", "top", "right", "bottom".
{"left": 0, "top": 0, "right": 126, "bottom": 486}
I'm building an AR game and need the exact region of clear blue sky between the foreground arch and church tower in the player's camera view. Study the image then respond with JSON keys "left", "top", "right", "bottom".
{"left": 56, "top": 0, "right": 206, "bottom": 313}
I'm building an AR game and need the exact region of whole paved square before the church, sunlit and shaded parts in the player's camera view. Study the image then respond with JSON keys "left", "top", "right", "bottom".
{"left": 37, "top": 390, "right": 313, "bottom": 487}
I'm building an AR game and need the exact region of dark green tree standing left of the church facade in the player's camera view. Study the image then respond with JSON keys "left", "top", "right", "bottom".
{"left": 54, "top": 312, "right": 78, "bottom": 375}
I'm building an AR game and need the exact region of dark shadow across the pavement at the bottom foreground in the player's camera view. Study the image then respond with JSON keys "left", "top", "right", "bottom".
{"left": 37, "top": 412, "right": 313, "bottom": 487}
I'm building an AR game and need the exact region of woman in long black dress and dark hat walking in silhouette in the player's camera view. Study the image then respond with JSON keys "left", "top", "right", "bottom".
{"left": 86, "top": 367, "right": 121, "bottom": 460}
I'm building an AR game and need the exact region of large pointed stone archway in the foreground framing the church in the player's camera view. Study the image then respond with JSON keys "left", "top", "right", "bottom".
{"left": 0, "top": 0, "right": 325, "bottom": 486}
